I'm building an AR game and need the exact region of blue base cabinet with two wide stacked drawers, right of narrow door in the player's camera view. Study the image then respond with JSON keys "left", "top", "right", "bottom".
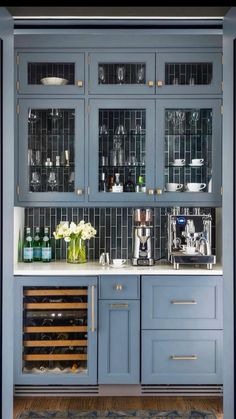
{"left": 141, "top": 275, "right": 223, "bottom": 385}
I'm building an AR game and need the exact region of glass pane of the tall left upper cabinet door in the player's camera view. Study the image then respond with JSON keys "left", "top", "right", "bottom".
{"left": 28, "top": 108, "right": 75, "bottom": 192}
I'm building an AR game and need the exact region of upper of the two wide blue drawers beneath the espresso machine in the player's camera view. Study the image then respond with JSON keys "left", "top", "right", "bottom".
{"left": 142, "top": 276, "right": 223, "bottom": 329}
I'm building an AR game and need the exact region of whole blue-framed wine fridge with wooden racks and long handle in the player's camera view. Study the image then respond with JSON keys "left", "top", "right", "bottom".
{"left": 14, "top": 276, "right": 97, "bottom": 385}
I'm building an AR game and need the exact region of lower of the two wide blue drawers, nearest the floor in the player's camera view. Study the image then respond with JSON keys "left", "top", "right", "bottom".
{"left": 141, "top": 330, "right": 222, "bottom": 384}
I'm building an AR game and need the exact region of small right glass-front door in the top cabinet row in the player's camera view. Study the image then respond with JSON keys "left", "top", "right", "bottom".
{"left": 156, "top": 52, "right": 222, "bottom": 94}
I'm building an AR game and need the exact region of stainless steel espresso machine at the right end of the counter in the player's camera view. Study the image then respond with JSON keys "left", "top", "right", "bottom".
{"left": 168, "top": 211, "right": 216, "bottom": 269}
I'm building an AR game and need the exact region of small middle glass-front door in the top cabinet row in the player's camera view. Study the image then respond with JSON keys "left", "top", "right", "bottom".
{"left": 89, "top": 52, "right": 155, "bottom": 94}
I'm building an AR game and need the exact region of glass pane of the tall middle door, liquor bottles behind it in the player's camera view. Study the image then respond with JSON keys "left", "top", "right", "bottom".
{"left": 98, "top": 109, "right": 146, "bottom": 192}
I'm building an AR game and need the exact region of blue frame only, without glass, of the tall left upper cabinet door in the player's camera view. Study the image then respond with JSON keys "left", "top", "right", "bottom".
{"left": 17, "top": 98, "right": 85, "bottom": 205}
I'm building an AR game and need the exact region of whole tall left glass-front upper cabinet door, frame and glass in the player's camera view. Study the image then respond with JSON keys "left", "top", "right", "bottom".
{"left": 18, "top": 99, "right": 84, "bottom": 202}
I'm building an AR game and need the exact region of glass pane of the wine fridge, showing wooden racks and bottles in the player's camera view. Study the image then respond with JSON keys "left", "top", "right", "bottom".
{"left": 22, "top": 287, "right": 88, "bottom": 374}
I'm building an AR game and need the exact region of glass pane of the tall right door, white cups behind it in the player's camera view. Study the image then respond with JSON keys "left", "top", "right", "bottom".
{"left": 165, "top": 108, "right": 212, "bottom": 192}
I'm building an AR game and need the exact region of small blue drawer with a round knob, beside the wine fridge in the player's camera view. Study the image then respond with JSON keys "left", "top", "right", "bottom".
{"left": 99, "top": 275, "right": 140, "bottom": 300}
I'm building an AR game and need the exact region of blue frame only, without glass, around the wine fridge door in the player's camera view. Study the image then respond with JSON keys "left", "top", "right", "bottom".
{"left": 14, "top": 276, "right": 98, "bottom": 385}
